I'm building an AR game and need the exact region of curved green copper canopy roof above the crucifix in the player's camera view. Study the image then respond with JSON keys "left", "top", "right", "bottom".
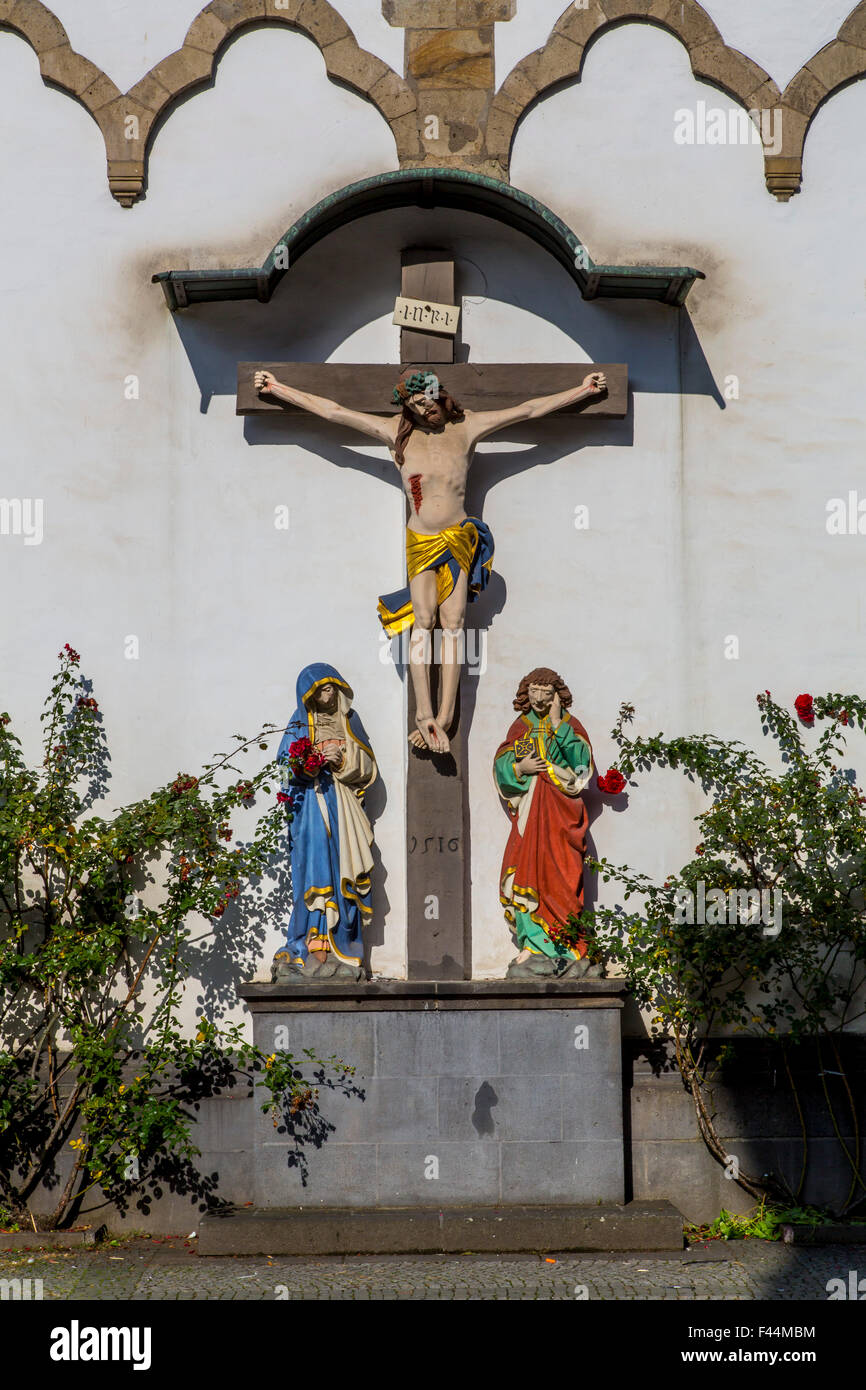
{"left": 153, "top": 168, "right": 706, "bottom": 313}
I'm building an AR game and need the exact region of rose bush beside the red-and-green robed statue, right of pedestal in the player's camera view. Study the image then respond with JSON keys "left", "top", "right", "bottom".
{"left": 581, "top": 691, "right": 866, "bottom": 1212}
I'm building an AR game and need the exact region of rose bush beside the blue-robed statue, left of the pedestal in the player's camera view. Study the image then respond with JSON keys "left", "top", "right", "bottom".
{"left": 0, "top": 644, "right": 352, "bottom": 1227}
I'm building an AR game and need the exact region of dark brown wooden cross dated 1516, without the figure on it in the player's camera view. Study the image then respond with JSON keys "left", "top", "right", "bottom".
{"left": 238, "top": 247, "right": 628, "bottom": 980}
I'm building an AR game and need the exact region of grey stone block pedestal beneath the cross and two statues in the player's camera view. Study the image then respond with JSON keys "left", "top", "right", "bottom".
{"left": 240, "top": 980, "right": 626, "bottom": 1211}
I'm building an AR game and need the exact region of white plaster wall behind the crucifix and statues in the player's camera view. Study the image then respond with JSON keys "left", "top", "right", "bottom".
{"left": 0, "top": 6, "right": 866, "bottom": 1028}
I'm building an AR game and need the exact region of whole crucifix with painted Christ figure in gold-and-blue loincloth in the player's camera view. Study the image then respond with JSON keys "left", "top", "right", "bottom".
{"left": 238, "top": 249, "right": 628, "bottom": 980}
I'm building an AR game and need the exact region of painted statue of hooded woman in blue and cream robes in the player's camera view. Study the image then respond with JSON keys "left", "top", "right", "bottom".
{"left": 271, "top": 662, "right": 378, "bottom": 983}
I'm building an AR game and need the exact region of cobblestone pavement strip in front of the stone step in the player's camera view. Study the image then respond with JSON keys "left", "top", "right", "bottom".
{"left": 0, "top": 1238, "right": 866, "bottom": 1301}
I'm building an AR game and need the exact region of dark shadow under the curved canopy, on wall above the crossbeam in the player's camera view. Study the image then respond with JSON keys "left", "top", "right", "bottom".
{"left": 164, "top": 209, "right": 724, "bottom": 411}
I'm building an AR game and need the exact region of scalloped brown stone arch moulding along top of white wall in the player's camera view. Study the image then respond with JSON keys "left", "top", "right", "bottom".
{"left": 0, "top": 0, "right": 866, "bottom": 207}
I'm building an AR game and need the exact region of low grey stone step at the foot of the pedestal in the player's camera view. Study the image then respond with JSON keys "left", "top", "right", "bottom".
{"left": 199, "top": 1202, "right": 683, "bottom": 1257}
